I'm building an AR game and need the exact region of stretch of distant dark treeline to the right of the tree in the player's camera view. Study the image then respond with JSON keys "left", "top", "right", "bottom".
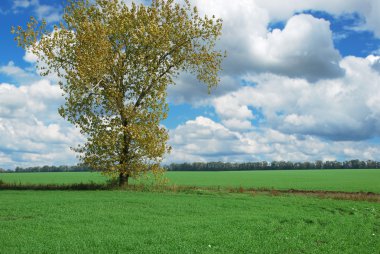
{"left": 165, "top": 160, "right": 380, "bottom": 171}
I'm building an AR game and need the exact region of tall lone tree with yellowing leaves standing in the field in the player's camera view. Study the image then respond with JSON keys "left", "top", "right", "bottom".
{"left": 12, "top": 0, "right": 224, "bottom": 185}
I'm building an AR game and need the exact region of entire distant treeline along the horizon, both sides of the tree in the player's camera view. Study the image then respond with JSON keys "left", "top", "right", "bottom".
{"left": 0, "top": 160, "right": 380, "bottom": 173}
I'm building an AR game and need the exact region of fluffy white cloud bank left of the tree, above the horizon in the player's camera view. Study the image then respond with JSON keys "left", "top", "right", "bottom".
{"left": 0, "top": 80, "right": 83, "bottom": 168}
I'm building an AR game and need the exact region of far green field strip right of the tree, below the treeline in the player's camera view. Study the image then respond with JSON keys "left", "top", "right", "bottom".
{"left": 168, "top": 170, "right": 380, "bottom": 193}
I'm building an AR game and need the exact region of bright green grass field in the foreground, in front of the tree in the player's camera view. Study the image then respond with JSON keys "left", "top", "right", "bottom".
{"left": 0, "top": 191, "right": 380, "bottom": 254}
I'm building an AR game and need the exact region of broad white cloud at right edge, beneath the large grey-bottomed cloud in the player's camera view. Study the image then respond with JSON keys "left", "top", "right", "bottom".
{"left": 212, "top": 56, "right": 380, "bottom": 140}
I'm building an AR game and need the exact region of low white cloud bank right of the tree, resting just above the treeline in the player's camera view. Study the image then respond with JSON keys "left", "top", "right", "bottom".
{"left": 166, "top": 117, "right": 380, "bottom": 163}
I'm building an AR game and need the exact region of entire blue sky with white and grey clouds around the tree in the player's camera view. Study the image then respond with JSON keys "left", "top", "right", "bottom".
{"left": 0, "top": 0, "right": 380, "bottom": 168}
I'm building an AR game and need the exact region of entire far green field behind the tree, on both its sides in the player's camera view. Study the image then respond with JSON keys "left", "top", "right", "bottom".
{"left": 0, "top": 169, "right": 380, "bottom": 193}
